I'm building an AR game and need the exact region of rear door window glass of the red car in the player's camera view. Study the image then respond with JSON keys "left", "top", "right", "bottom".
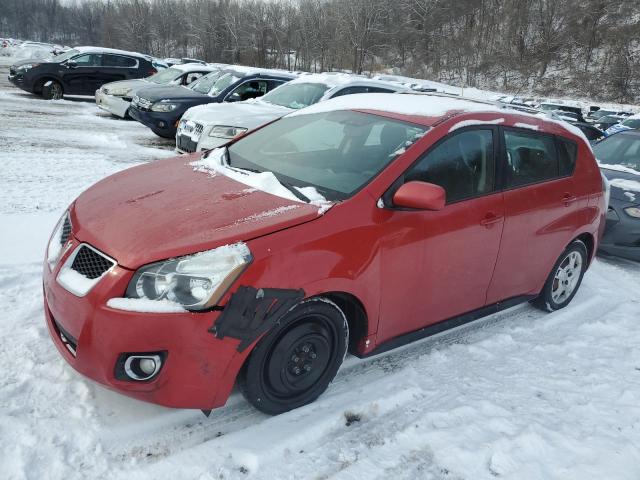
{"left": 504, "top": 129, "right": 560, "bottom": 188}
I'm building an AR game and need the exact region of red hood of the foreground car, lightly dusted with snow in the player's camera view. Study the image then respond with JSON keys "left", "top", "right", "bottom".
{"left": 71, "top": 155, "right": 320, "bottom": 269}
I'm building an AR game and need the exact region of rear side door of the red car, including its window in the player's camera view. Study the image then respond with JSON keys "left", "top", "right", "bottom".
{"left": 487, "top": 128, "right": 585, "bottom": 303}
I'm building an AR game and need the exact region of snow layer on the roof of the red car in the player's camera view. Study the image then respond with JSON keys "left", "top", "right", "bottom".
{"left": 289, "top": 93, "right": 505, "bottom": 122}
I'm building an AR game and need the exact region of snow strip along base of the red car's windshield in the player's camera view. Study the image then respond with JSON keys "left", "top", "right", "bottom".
{"left": 191, "top": 147, "right": 333, "bottom": 215}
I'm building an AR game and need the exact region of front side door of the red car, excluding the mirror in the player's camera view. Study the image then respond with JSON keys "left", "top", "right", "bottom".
{"left": 378, "top": 127, "right": 504, "bottom": 343}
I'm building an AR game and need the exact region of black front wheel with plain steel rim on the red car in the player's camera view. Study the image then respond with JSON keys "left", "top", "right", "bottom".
{"left": 238, "top": 298, "right": 349, "bottom": 415}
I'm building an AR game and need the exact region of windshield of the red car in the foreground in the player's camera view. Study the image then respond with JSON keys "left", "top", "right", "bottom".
{"left": 228, "top": 110, "right": 426, "bottom": 200}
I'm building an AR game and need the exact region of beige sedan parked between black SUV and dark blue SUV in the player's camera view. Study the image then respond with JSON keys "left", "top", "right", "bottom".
{"left": 96, "top": 63, "right": 224, "bottom": 118}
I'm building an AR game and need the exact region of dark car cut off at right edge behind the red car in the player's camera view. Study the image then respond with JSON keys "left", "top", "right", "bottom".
{"left": 593, "top": 130, "right": 640, "bottom": 261}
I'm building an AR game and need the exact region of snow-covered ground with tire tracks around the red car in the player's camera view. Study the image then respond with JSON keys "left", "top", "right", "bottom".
{"left": 0, "top": 54, "right": 640, "bottom": 480}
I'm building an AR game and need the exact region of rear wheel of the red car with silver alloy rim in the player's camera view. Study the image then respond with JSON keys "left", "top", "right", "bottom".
{"left": 531, "top": 240, "right": 588, "bottom": 312}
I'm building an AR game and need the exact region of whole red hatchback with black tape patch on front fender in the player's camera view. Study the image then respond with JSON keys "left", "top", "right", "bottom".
{"left": 44, "top": 93, "right": 606, "bottom": 414}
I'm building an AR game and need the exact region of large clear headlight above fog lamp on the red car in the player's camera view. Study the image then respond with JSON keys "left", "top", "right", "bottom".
{"left": 126, "top": 243, "right": 252, "bottom": 310}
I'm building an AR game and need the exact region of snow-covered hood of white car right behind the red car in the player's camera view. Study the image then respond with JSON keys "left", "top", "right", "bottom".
{"left": 183, "top": 101, "right": 292, "bottom": 129}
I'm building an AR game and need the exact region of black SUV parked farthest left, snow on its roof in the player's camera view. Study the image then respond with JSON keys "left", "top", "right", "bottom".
{"left": 9, "top": 47, "right": 157, "bottom": 99}
